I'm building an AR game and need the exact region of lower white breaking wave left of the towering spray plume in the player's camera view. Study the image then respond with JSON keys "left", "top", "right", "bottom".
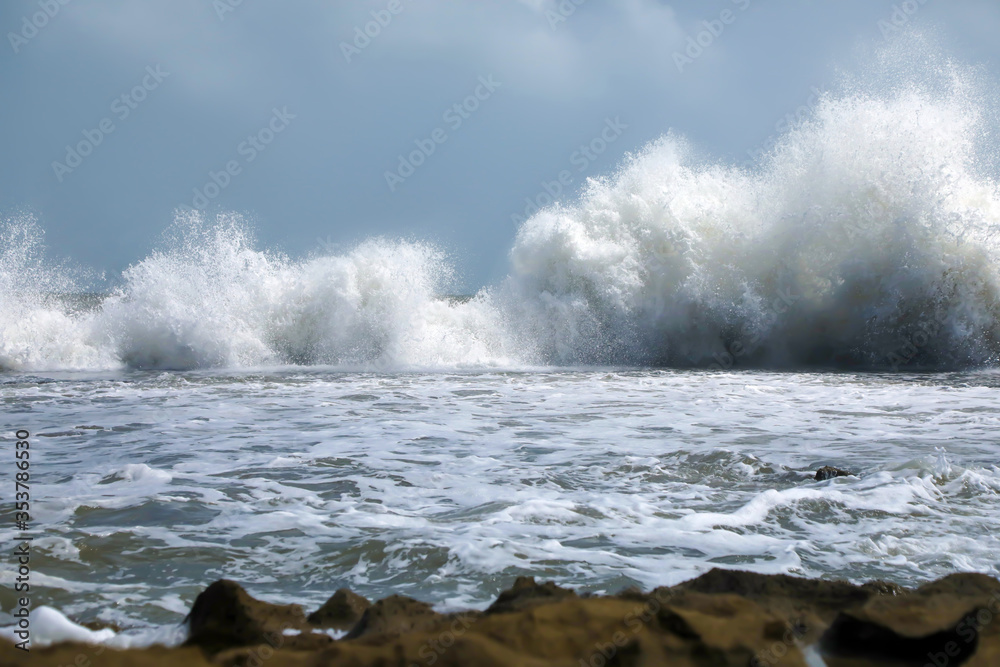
{"left": 0, "top": 212, "right": 503, "bottom": 370}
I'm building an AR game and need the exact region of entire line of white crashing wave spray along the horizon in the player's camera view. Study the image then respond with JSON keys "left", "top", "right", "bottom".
{"left": 0, "top": 38, "right": 1000, "bottom": 370}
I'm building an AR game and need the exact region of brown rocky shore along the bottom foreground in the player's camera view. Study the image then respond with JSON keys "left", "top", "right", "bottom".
{"left": 0, "top": 569, "right": 1000, "bottom": 667}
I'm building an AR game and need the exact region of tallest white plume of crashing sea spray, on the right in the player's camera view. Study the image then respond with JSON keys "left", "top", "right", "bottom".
{"left": 505, "top": 41, "right": 1000, "bottom": 368}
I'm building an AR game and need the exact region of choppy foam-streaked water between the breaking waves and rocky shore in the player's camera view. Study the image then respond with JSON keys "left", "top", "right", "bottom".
{"left": 0, "top": 368, "right": 1000, "bottom": 636}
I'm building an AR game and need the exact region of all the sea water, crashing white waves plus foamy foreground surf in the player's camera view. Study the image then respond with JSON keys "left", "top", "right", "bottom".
{"left": 0, "top": 39, "right": 1000, "bottom": 645}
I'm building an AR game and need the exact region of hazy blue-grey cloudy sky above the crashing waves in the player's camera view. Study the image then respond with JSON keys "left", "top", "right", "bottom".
{"left": 0, "top": 0, "right": 1000, "bottom": 291}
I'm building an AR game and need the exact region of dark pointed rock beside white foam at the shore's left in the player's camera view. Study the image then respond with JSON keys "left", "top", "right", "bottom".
{"left": 184, "top": 579, "right": 333, "bottom": 654}
